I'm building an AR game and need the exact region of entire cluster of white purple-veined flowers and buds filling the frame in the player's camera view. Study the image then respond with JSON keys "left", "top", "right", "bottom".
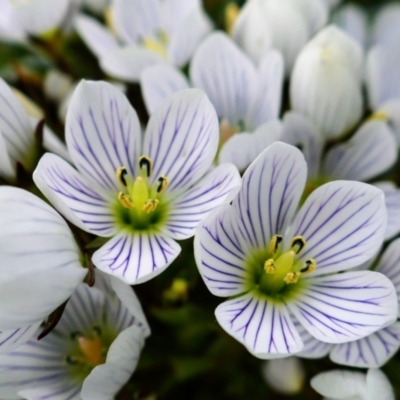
{"left": 0, "top": 0, "right": 400, "bottom": 400}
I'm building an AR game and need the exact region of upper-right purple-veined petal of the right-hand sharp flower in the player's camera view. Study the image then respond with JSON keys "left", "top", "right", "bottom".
{"left": 285, "top": 181, "right": 387, "bottom": 276}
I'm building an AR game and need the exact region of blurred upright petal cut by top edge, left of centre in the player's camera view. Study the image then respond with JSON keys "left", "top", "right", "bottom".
{"left": 112, "top": 0, "right": 161, "bottom": 44}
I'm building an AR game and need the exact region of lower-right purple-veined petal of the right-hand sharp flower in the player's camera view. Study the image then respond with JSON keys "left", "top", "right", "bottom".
{"left": 288, "top": 271, "right": 397, "bottom": 343}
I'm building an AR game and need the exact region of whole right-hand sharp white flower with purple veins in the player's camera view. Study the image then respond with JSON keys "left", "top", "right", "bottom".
{"left": 195, "top": 142, "right": 397, "bottom": 359}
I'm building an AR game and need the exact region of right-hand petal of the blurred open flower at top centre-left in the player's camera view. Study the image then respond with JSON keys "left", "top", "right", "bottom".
{"left": 168, "top": 6, "right": 212, "bottom": 67}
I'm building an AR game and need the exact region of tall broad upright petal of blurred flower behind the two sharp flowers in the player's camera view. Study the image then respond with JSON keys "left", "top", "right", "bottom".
{"left": 190, "top": 32, "right": 257, "bottom": 126}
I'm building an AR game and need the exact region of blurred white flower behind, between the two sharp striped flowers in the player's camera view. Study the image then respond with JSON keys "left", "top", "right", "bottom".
{"left": 140, "top": 32, "right": 283, "bottom": 171}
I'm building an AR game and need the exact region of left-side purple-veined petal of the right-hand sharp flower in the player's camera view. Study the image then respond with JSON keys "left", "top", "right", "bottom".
{"left": 194, "top": 205, "right": 248, "bottom": 297}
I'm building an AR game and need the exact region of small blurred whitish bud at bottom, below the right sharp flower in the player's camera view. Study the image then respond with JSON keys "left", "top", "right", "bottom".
{"left": 262, "top": 357, "right": 306, "bottom": 395}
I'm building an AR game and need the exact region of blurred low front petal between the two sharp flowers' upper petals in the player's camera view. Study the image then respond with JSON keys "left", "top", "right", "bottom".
{"left": 218, "top": 120, "right": 283, "bottom": 171}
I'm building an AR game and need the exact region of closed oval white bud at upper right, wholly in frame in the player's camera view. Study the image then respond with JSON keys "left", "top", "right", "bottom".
{"left": 290, "top": 26, "right": 363, "bottom": 138}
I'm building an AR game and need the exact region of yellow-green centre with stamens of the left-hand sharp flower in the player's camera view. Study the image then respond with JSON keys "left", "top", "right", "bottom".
{"left": 113, "top": 156, "right": 169, "bottom": 231}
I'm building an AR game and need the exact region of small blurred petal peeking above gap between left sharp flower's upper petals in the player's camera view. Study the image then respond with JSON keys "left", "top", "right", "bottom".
{"left": 140, "top": 64, "right": 189, "bottom": 114}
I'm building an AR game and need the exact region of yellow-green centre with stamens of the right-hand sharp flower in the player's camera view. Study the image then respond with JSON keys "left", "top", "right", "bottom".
{"left": 245, "top": 235, "right": 316, "bottom": 302}
